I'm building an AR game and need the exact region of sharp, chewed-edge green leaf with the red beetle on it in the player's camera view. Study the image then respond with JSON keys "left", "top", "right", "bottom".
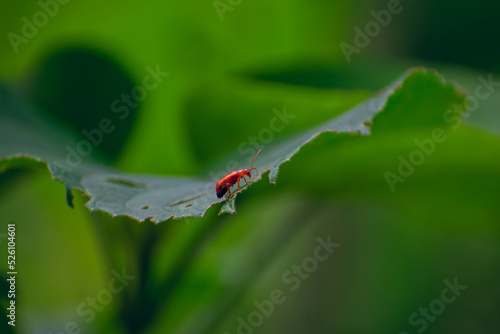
{"left": 0, "top": 69, "right": 463, "bottom": 223}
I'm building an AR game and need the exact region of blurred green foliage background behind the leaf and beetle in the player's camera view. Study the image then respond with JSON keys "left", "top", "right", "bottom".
{"left": 0, "top": 0, "right": 500, "bottom": 334}
